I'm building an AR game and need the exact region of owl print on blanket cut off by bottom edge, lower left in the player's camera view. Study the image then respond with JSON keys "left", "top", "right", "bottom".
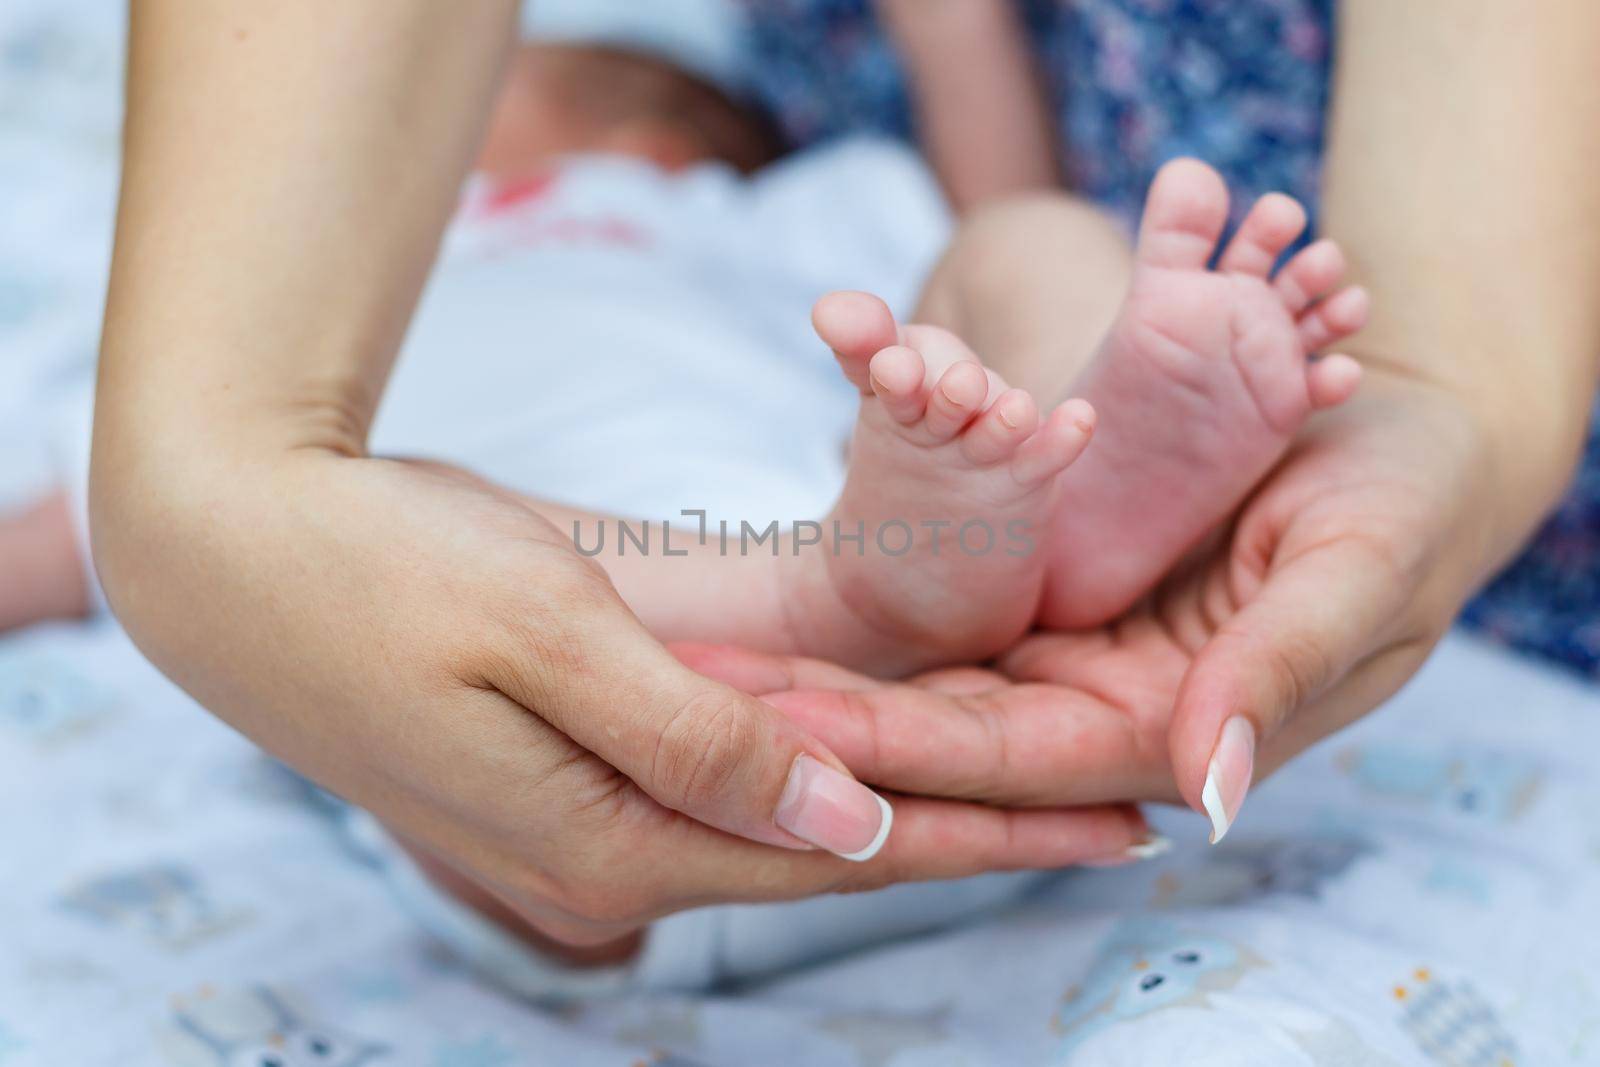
{"left": 162, "top": 985, "right": 389, "bottom": 1067}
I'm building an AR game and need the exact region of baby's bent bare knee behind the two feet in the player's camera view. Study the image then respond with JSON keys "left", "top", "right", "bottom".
{"left": 915, "top": 194, "right": 1133, "bottom": 403}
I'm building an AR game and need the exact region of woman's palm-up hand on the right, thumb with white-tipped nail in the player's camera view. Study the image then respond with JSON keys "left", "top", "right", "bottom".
{"left": 688, "top": 370, "right": 1531, "bottom": 837}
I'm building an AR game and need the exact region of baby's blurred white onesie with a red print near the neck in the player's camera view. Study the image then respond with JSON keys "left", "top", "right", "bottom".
{"left": 373, "top": 142, "right": 947, "bottom": 522}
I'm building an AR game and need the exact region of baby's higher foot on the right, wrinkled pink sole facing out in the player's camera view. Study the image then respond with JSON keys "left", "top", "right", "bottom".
{"left": 1042, "top": 160, "right": 1368, "bottom": 627}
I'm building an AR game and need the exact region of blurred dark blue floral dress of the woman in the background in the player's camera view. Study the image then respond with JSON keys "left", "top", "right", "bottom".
{"left": 744, "top": 0, "right": 1600, "bottom": 678}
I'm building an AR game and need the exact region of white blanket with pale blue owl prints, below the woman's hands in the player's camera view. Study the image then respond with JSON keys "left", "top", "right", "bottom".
{"left": 0, "top": 625, "right": 1600, "bottom": 1067}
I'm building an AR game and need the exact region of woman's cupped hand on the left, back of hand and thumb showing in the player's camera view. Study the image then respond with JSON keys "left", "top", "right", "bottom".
{"left": 94, "top": 451, "right": 1146, "bottom": 944}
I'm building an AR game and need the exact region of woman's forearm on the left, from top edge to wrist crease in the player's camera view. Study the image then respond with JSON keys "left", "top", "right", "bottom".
{"left": 98, "top": 0, "right": 515, "bottom": 462}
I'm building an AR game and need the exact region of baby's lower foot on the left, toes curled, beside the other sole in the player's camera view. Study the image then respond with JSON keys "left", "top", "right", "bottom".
{"left": 797, "top": 293, "right": 1094, "bottom": 672}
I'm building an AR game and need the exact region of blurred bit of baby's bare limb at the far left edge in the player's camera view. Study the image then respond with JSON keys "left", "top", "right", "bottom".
{"left": 0, "top": 493, "right": 91, "bottom": 633}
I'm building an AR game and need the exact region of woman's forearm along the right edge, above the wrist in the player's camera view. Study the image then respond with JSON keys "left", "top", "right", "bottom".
{"left": 1325, "top": 0, "right": 1600, "bottom": 565}
